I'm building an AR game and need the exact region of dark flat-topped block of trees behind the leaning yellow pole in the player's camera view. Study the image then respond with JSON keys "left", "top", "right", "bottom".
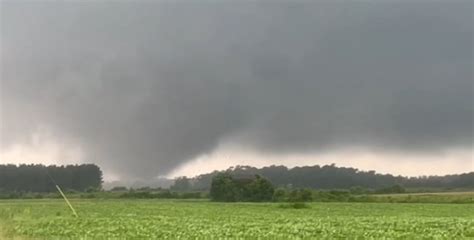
{"left": 0, "top": 164, "right": 102, "bottom": 193}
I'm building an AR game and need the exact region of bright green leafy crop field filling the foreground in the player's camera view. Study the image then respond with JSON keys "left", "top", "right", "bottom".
{"left": 0, "top": 199, "right": 474, "bottom": 239}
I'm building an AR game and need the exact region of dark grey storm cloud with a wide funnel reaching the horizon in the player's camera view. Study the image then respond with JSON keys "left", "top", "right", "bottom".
{"left": 1, "top": 1, "right": 474, "bottom": 176}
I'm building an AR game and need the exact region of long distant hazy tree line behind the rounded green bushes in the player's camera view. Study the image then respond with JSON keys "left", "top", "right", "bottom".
{"left": 173, "top": 164, "right": 474, "bottom": 191}
